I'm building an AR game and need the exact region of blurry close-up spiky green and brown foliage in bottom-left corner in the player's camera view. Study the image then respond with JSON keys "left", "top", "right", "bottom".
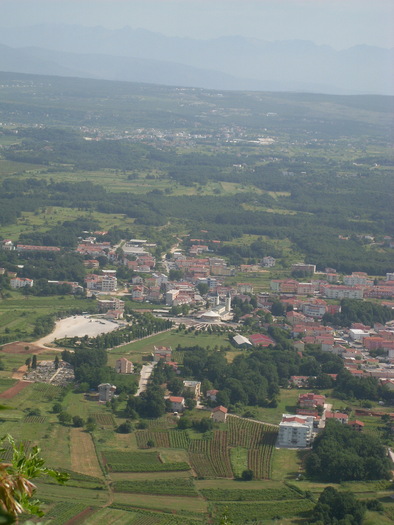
{"left": 0, "top": 435, "right": 69, "bottom": 523}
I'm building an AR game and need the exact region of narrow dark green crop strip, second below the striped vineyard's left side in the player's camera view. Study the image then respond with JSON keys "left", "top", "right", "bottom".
{"left": 114, "top": 478, "right": 198, "bottom": 497}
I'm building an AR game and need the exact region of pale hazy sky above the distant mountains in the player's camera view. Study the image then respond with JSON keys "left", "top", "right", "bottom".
{"left": 0, "top": 0, "right": 394, "bottom": 49}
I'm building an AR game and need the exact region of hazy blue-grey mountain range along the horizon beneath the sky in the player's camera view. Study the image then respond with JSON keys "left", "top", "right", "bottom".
{"left": 0, "top": 25, "right": 394, "bottom": 95}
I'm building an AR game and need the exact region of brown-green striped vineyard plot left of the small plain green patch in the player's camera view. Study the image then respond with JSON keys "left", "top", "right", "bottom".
{"left": 189, "top": 430, "right": 233, "bottom": 478}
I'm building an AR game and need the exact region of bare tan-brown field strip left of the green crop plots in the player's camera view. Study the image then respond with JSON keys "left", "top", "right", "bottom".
{"left": 70, "top": 428, "right": 103, "bottom": 478}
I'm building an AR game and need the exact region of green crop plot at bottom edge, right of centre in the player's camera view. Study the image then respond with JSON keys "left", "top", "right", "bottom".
{"left": 213, "top": 499, "right": 314, "bottom": 525}
